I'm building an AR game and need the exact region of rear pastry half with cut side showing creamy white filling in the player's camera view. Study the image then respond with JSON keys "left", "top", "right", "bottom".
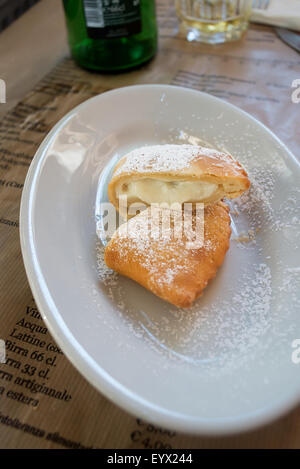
{"left": 108, "top": 145, "right": 250, "bottom": 209}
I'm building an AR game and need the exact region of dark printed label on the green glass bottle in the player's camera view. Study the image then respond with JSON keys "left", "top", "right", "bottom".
{"left": 83, "top": 0, "right": 142, "bottom": 39}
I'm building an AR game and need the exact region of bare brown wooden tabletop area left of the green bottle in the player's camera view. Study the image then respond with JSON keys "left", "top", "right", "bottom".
{"left": 0, "top": 0, "right": 69, "bottom": 117}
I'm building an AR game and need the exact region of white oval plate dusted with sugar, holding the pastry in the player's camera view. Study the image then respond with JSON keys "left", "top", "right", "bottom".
{"left": 20, "top": 85, "right": 300, "bottom": 434}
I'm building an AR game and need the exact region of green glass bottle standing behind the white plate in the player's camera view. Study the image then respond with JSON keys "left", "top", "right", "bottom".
{"left": 63, "top": 0, "right": 157, "bottom": 72}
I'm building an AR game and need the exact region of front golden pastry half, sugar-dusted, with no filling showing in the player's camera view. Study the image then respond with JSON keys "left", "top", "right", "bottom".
{"left": 105, "top": 202, "right": 231, "bottom": 308}
